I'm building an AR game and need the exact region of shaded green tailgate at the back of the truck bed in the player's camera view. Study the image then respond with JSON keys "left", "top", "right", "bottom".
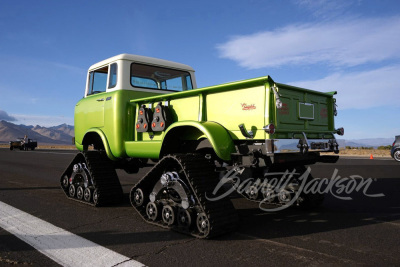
{"left": 269, "top": 84, "right": 336, "bottom": 139}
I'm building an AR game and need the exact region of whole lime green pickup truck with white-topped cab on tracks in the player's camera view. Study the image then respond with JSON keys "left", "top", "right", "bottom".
{"left": 61, "top": 54, "right": 344, "bottom": 238}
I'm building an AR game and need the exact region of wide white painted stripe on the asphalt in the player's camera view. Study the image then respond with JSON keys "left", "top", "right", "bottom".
{"left": 0, "top": 201, "right": 144, "bottom": 267}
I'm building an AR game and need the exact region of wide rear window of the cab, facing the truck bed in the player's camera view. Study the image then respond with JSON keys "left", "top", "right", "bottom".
{"left": 131, "top": 63, "right": 193, "bottom": 91}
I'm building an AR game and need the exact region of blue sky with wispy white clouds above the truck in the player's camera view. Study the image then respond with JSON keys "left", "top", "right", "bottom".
{"left": 0, "top": 0, "right": 400, "bottom": 139}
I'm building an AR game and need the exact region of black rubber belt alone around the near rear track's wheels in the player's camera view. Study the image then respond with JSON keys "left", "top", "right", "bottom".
{"left": 130, "top": 154, "right": 238, "bottom": 238}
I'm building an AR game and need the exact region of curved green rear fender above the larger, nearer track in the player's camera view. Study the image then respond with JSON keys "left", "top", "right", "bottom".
{"left": 164, "top": 121, "right": 236, "bottom": 160}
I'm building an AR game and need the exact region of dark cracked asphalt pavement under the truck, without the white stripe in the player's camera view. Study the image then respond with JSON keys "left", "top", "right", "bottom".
{"left": 0, "top": 149, "right": 400, "bottom": 266}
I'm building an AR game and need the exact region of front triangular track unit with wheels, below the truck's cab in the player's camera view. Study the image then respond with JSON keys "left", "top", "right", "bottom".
{"left": 60, "top": 151, "right": 123, "bottom": 206}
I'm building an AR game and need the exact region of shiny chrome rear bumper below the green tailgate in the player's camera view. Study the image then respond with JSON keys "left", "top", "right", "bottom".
{"left": 265, "top": 133, "right": 339, "bottom": 155}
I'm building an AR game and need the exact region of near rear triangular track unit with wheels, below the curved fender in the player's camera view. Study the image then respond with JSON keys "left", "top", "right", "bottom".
{"left": 130, "top": 154, "right": 238, "bottom": 238}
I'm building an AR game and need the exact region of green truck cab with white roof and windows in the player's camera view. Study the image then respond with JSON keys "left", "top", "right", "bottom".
{"left": 75, "top": 54, "right": 197, "bottom": 159}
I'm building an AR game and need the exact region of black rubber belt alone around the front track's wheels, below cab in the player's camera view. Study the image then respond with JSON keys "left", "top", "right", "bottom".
{"left": 60, "top": 151, "right": 123, "bottom": 207}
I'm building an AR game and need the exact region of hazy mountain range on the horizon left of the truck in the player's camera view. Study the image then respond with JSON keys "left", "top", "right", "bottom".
{"left": 0, "top": 120, "right": 74, "bottom": 145}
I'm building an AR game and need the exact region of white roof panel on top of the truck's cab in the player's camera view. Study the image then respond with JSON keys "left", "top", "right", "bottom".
{"left": 89, "top": 54, "right": 194, "bottom": 71}
